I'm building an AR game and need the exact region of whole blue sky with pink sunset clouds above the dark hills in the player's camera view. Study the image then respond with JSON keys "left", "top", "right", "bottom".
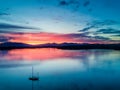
{"left": 0, "top": 0, "right": 120, "bottom": 44}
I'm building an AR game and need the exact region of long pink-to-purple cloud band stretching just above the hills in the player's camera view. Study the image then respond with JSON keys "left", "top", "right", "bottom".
{"left": 1, "top": 32, "right": 118, "bottom": 44}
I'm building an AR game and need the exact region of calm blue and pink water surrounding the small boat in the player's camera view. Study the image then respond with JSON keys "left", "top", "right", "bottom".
{"left": 0, "top": 49, "right": 120, "bottom": 90}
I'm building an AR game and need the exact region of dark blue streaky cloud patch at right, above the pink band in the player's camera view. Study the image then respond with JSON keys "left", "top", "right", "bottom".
{"left": 79, "top": 20, "right": 120, "bottom": 42}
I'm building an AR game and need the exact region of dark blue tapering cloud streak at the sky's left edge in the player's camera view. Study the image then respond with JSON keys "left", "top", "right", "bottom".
{"left": 0, "top": 23, "right": 38, "bottom": 33}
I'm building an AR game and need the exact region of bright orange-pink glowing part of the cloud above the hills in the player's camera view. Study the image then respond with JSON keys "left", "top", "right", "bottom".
{"left": 5, "top": 33, "right": 80, "bottom": 44}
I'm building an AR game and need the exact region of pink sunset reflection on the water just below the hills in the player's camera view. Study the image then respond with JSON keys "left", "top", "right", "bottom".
{"left": 0, "top": 48, "right": 90, "bottom": 60}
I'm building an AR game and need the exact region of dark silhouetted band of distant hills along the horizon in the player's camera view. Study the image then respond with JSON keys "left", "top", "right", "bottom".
{"left": 0, "top": 42, "right": 120, "bottom": 50}
